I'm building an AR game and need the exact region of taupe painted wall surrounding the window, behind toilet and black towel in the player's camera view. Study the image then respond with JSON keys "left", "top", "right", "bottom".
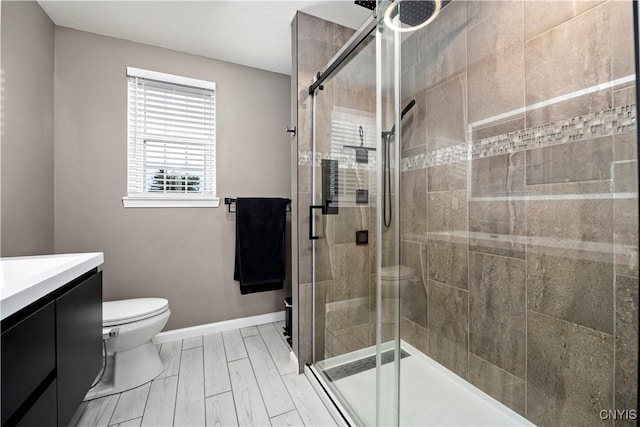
{"left": 55, "top": 27, "right": 291, "bottom": 329}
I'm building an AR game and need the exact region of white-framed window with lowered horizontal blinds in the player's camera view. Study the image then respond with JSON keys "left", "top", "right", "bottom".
{"left": 122, "top": 67, "right": 220, "bottom": 207}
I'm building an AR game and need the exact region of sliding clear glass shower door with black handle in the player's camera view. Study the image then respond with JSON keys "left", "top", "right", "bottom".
{"left": 310, "top": 5, "right": 401, "bottom": 425}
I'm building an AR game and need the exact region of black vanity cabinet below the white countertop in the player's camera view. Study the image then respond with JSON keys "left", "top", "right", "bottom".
{"left": 0, "top": 269, "right": 103, "bottom": 427}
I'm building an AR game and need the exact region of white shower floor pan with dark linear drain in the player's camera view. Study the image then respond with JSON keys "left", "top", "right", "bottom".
{"left": 314, "top": 341, "right": 534, "bottom": 426}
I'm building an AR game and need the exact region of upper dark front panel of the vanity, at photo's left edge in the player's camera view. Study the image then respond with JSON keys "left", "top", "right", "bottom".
{"left": 0, "top": 302, "right": 56, "bottom": 425}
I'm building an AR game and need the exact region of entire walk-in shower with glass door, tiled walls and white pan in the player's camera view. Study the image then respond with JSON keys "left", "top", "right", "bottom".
{"left": 297, "top": 0, "right": 638, "bottom": 425}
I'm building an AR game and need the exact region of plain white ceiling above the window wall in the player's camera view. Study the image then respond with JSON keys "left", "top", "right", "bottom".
{"left": 38, "top": 0, "right": 370, "bottom": 74}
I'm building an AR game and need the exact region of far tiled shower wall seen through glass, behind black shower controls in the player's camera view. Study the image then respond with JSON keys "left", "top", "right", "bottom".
{"left": 315, "top": 37, "right": 378, "bottom": 360}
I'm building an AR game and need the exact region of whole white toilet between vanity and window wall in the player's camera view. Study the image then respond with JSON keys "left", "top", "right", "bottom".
{"left": 85, "top": 298, "right": 171, "bottom": 400}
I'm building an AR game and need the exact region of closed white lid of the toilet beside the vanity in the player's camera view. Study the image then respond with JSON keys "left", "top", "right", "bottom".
{"left": 102, "top": 298, "right": 169, "bottom": 326}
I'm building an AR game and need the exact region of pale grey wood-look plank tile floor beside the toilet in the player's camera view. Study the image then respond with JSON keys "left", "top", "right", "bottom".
{"left": 71, "top": 322, "right": 336, "bottom": 427}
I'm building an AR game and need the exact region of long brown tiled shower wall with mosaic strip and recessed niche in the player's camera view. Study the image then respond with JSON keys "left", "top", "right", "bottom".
{"left": 401, "top": 0, "right": 638, "bottom": 425}
